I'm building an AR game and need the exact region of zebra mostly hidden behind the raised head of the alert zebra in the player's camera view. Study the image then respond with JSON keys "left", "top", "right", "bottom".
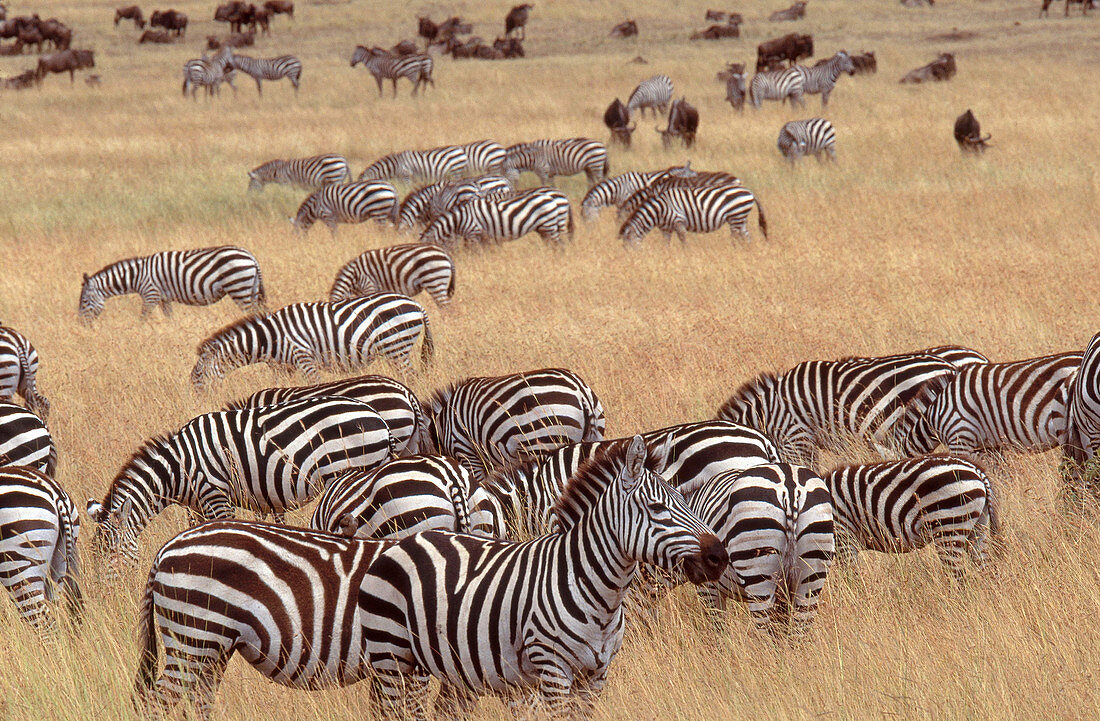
{"left": 485, "top": 420, "right": 779, "bottom": 535}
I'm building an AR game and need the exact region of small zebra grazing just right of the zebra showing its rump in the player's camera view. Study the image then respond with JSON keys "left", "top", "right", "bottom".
{"left": 823, "top": 456, "right": 998, "bottom": 576}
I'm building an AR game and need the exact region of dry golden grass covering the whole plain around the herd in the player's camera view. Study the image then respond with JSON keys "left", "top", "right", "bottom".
{"left": 0, "top": 0, "right": 1100, "bottom": 720}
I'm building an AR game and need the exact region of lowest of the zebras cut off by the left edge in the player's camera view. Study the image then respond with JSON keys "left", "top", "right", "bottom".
{"left": 0, "top": 468, "right": 83, "bottom": 638}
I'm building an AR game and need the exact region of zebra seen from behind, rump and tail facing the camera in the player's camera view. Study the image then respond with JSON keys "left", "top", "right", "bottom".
{"left": 684, "top": 463, "right": 836, "bottom": 636}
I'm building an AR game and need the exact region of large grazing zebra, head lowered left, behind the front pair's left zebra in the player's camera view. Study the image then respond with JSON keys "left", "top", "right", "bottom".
{"left": 88, "top": 397, "right": 395, "bottom": 573}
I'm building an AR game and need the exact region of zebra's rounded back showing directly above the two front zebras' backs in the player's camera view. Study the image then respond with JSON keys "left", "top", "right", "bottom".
{"left": 309, "top": 456, "right": 504, "bottom": 538}
